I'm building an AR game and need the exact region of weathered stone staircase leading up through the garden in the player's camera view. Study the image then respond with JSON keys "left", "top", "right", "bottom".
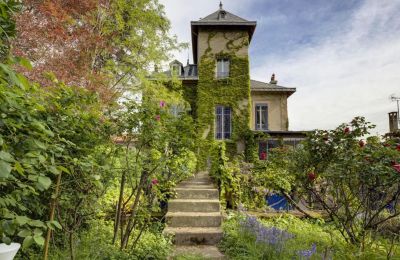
{"left": 164, "top": 172, "right": 222, "bottom": 258}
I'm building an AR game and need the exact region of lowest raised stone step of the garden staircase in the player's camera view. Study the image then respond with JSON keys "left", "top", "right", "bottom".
{"left": 164, "top": 227, "right": 222, "bottom": 245}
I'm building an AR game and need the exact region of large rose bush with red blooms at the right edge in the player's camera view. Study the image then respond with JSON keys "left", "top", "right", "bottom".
{"left": 292, "top": 118, "right": 400, "bottom": 243}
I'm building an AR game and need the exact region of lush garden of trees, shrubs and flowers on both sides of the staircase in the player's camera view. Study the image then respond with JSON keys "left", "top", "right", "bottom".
{"left": 0, "top": 0, "right": 400, "bottom": 260}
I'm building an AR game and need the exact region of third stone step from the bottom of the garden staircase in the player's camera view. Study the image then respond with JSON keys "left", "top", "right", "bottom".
{"left": 168, "top": 199, "right": 220, "bottom": 212}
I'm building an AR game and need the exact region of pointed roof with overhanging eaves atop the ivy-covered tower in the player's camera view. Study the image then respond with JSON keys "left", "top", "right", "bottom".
{"left": 191, "top": 3, "right": 257, "bottom": 63}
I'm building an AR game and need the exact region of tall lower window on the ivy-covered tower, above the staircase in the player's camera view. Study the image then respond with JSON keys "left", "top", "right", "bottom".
{"left": 215, "top": 106, "right": 232, "bottom": 140}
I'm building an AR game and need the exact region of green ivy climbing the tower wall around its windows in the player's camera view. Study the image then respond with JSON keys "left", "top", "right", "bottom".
{"left": 196, "top": 30, "right": 251, "bottom": 169}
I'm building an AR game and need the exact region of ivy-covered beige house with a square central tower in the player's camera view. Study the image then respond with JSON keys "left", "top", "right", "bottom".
{"left": 159, "top": 4, "right": 304, "bottom": 167}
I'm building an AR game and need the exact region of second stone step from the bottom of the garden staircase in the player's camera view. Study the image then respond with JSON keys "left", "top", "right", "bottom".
{"left": 166, "top": 212, "right": 222, "bottom": 227}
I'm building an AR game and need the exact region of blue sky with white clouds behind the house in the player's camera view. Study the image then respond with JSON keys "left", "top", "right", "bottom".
{"left": 160, "top": 0, "right": 400, "bottom": 134}
